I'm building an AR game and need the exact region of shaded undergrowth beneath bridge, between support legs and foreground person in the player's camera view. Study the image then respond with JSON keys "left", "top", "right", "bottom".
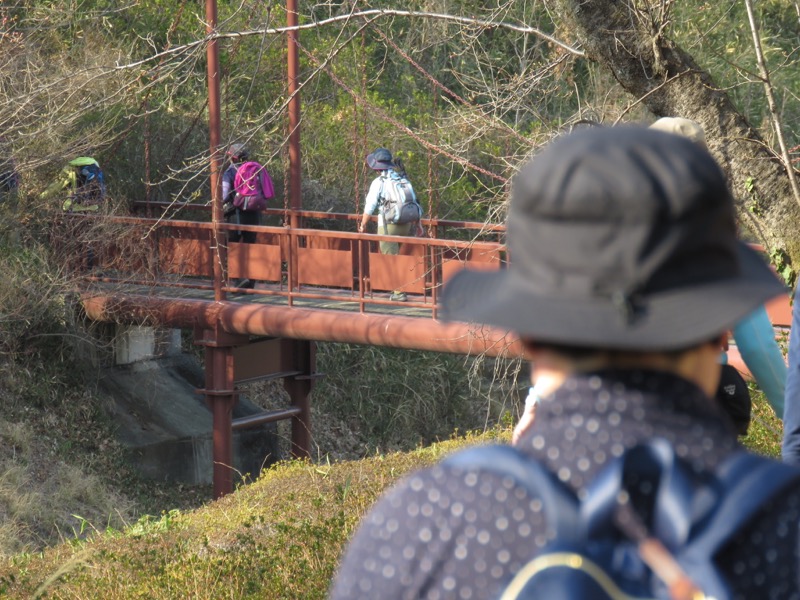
{"left": 312, "top": 343, "right": 528, "bottom": 458}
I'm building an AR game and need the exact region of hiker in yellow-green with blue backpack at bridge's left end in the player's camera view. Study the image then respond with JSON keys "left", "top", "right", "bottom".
{"left": 40, "top": 156, "right": 106, "bottom": 212}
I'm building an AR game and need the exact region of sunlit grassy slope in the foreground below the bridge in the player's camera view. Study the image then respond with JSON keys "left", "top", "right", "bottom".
{"left": 0, "top": 392, "right": 781, "bottom": 599}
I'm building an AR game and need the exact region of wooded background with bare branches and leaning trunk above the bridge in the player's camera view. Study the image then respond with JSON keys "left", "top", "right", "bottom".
{"left": 0, "top": 0, "right": 800, "bottom": 283}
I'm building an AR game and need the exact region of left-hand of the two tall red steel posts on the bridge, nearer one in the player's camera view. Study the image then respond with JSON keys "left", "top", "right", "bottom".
{"left": 206, "top": 0, "right": 227, "bottom": 302}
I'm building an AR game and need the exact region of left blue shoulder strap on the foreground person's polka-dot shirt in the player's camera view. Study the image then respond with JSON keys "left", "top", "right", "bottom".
{"left": 442, "top": 444, "right": 583, "bottom": 542}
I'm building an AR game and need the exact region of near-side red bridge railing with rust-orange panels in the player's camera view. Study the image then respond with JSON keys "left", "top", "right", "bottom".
{"left": 69, "top": 206, "right": 508, "bottom": 317}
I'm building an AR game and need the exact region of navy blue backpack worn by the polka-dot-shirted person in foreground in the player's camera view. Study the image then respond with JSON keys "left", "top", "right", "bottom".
{"left": 444, "top": 439, "right": 800, "bottom": 600}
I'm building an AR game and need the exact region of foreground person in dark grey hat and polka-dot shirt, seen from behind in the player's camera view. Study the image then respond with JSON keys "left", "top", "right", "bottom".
{"left": 331, "top": 126, "right": 800, "bottom": 600}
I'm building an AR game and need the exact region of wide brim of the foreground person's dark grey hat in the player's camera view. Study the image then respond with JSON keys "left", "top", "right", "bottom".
{"left": 442, "top": 242, "right": 788, "bottom": 351}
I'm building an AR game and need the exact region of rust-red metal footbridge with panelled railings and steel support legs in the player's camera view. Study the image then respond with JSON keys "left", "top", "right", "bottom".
{"left": 75, "top": 204, "right": 520, "bottom": 496}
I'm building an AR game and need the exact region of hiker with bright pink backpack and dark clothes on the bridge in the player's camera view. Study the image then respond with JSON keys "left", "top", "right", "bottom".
{"left": 222, "top": 144, "right": 275, "bottom": 289}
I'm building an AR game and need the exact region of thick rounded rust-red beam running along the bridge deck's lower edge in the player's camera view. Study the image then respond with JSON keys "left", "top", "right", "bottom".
{"left": 83, "top": 293, "right": 522, "bottom": 358}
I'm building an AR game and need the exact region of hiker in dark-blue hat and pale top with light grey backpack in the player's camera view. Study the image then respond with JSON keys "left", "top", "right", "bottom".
{"left": 358, "top": 148, "right": 423, "bottom": 302}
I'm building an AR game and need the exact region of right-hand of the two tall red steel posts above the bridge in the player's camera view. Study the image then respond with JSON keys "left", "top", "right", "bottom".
{"left": 286, "top": 0, "right": 303, "bottom": 229}
